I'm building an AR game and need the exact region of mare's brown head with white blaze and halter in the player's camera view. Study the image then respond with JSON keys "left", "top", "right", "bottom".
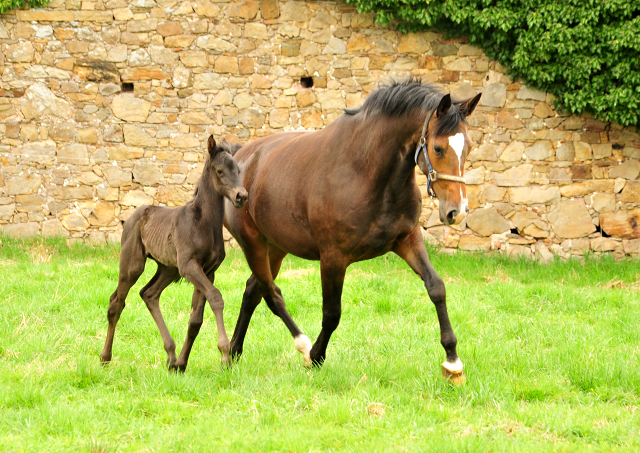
{"left": 415, "top": 94, "right": 480, "bottom": 225}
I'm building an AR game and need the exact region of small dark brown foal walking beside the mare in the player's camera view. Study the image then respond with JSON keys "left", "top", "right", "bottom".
{"left": 100, "top": 136, "right": 247, "bottom": 371}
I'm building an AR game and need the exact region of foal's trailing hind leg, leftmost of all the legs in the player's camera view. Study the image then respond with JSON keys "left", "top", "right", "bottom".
{"left": 100, "top": 228, "right": 146, "bottom": 363}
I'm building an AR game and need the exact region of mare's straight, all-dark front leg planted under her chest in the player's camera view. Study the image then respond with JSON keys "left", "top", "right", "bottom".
{"left": 311, "top": 255, "right": 347, "bottom": 366}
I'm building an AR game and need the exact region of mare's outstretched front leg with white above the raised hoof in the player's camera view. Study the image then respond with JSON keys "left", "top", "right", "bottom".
{"left": 393, "top": 226, "right": 466, "bottom": 385}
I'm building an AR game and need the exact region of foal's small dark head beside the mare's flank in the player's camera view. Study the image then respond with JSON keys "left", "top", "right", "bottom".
{"left": 205, "top": 135, "right": 248, "bottom": 208}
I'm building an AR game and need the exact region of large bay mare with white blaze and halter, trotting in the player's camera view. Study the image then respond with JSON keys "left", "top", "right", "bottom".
{"left": 225, "top": 78, "right": 480, "bottom": 381}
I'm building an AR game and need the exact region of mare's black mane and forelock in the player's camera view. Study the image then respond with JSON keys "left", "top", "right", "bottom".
{"left": 344, "top": 77, "right": 464, "bottom": 135}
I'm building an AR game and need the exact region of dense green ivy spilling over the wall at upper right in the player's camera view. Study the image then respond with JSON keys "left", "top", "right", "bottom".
{"left": 346, "top": 0, "right": 640, "bottom": 125}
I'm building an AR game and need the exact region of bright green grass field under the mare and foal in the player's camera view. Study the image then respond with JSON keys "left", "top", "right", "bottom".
{"left": 0, "top": 238, "right": 640, "bottom": 452}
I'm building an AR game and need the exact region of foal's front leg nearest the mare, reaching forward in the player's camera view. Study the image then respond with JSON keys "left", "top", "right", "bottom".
{"left": 180, "top": 260, "right": 231, "bottom": 367}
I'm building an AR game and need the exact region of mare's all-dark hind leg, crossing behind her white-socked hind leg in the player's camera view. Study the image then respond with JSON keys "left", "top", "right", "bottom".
{"left": 231, "top": 247, "right": 287, "bottom": 359}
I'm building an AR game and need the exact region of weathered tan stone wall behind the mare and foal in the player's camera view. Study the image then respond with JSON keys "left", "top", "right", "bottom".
{"left": 0, "top": 0, "right": 640, "bottom": 259}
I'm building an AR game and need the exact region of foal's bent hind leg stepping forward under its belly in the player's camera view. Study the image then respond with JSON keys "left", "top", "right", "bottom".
{"left": 140, "top": 263, "right": 178, "bottom": 369}
